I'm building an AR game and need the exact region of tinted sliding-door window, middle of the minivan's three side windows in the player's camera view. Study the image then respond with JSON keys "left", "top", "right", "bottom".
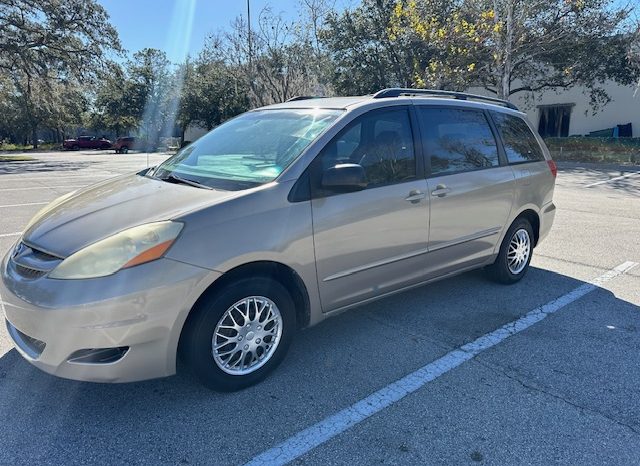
{"left": 418, "top": 107, "right": 500, "bottom": 174}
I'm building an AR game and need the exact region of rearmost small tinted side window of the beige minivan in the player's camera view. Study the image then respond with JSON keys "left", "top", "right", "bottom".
{"left": 492, "top": 112, "right": 544, "bottom": 163}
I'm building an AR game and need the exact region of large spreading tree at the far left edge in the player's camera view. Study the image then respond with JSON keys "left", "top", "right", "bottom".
{"left": 0, "top": 0, "right": 120, "bottom": 147}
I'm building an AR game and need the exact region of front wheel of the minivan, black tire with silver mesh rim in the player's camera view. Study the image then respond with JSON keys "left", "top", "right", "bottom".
{"left": 180, "top": 277, "right": 296, "bottom": 391}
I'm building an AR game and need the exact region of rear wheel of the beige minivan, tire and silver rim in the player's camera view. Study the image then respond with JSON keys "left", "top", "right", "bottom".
{"left": 487, "top": 218, "right": 534, "bottom": 285}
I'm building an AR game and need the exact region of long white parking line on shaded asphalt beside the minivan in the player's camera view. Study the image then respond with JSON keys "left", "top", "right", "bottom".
{"left": 247, "top": 262, "right": 638, "bottom": 466}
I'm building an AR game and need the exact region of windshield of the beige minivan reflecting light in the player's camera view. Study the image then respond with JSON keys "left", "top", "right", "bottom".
{"left": 151, "top": 109, "right": 341, "bottom": 190}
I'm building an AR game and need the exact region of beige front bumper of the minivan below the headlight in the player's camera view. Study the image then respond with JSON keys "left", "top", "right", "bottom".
{"left": 0, "top": 251, "right": 220, "bottom": 382}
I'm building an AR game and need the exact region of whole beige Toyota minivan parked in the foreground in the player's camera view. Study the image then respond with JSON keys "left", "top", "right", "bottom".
{"left": 0, "top": 89, "right": 557, "bottom": 390}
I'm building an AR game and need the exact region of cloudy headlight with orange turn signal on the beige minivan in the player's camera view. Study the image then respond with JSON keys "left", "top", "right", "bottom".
{"left": 49, "top": 221, "right": 183, "bottom": 279}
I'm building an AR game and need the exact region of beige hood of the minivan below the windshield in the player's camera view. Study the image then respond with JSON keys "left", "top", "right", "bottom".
{"left": 23, "top": 174, "right": 238, "bottom": 257}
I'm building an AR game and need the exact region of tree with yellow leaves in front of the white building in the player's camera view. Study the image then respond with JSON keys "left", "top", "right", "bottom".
{"left": 390, "top": 0, "right": 637, "bottom": 108}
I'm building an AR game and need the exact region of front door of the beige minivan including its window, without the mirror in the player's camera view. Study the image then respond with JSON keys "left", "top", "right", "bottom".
{"left": 311, "top": 107, "right": 429, "bottom": 312}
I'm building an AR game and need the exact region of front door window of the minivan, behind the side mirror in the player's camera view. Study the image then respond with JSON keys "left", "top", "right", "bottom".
{"left": 319, "top": 109, "right": 416, "bottom": 187}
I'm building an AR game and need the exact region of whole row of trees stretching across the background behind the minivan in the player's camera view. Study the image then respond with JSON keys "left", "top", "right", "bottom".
{"left": 0, "top": 0, "right": 640, "bottom": 147}
